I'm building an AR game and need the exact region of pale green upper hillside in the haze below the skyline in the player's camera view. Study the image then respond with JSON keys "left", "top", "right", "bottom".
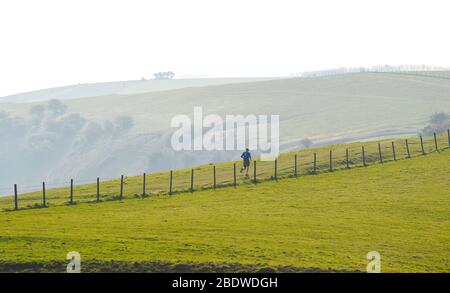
{"left": 5, "top": 73, "right": 450, "bottom": 140}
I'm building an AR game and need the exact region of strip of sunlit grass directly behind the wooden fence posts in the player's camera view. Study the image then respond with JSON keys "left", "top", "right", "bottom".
{"left": 0, "top": 132, "right": 449, "bottom": 210}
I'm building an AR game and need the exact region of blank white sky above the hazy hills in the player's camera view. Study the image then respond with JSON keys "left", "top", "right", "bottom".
{"left": 0, "top": 0, "right": 450, "bottom": 96}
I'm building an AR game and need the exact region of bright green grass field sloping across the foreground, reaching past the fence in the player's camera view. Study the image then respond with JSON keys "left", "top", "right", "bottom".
{"left": 0, "top": 132, "right": 450, "bottom": 272}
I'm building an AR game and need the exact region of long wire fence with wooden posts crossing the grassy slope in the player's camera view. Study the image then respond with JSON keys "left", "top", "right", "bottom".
{"left": 0, "top": 130, "right": 450, "bottom": 211}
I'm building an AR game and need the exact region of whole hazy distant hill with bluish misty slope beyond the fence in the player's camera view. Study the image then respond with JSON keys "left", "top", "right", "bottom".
{"left": 0, "top": 73, "right": 450, "bottom": 193}
